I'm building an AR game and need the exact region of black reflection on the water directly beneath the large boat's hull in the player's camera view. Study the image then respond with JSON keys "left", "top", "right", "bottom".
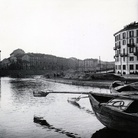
{"left": 91, "top": 127, "right": 138, "bottom": 138}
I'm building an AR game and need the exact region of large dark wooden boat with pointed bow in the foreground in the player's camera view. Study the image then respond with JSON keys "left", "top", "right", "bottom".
{"left": 89, "top": 93, "right": 138, "bottom": 133}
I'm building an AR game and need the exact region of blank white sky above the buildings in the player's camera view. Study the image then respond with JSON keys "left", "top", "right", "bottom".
{"left": 0, "top": 0, "right": 138, "bottom": 61}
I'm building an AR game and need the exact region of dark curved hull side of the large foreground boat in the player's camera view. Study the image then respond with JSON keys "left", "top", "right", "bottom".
{"left": 89, "top": 94, "right": 138, "bottom": 133}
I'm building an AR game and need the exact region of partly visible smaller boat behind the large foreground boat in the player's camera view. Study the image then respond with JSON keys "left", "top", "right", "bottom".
{"left": 110, "top": 81, "right": 138, "bottom": 93}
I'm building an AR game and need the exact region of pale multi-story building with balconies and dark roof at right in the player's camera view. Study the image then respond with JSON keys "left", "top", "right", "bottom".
{"left": 114, "top": 22, "right": 138, "bottom": 74}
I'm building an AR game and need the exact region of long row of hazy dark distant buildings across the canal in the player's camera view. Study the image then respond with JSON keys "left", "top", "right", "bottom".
{"left": 0, "top": 49, "right": 112, "bottom": 72}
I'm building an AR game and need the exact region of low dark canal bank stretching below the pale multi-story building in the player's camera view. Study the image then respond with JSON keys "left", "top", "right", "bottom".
{"left": 43, "top": 73, "right": 138, "bottom": 88}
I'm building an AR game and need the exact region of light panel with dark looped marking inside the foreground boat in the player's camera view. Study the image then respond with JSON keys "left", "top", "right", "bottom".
{"left": 107, "top": 98, "right": 133, "bottom": 111}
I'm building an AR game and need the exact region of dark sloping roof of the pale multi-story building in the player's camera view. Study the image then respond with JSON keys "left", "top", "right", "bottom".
{"left": 114, "top": 22, "right": 138, "bottom": 36}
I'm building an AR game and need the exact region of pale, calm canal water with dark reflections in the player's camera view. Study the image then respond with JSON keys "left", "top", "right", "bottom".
{"left": 0, "top": 76, "right": 136, "bottom": 138}
